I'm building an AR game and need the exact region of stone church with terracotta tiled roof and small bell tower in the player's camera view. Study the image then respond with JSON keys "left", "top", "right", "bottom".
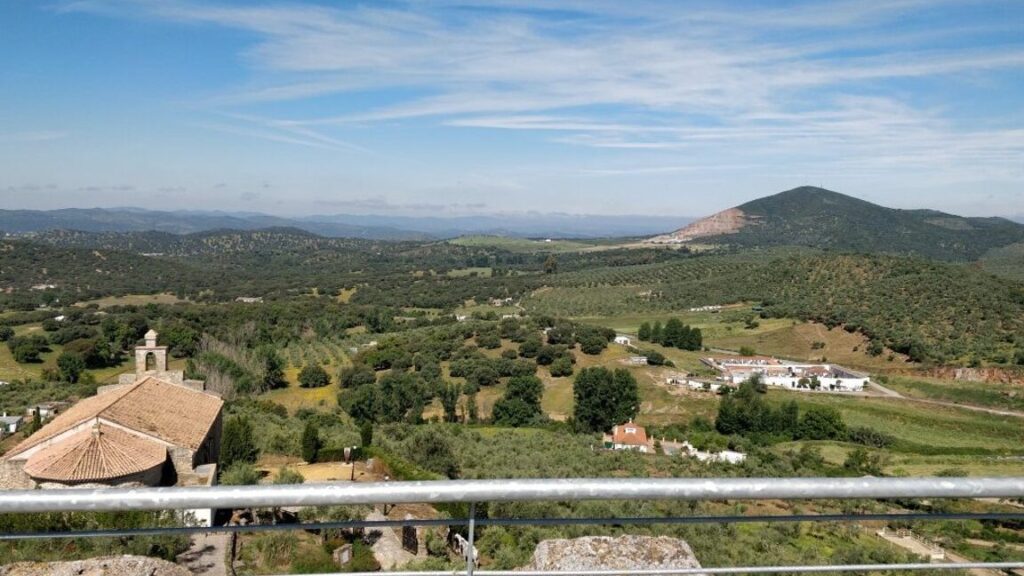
{"left": 0, "top": 330, "right": 223, "bottom": 490}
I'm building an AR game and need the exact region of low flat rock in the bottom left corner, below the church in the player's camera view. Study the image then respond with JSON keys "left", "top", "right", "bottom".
{"left": 0, "top": 556, "right": 193, "bottom": 576}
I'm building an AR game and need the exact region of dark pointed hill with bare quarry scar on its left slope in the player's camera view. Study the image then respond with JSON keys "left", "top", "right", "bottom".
{"left": 652, "top": 187, "right": 1024, "bottom": 261}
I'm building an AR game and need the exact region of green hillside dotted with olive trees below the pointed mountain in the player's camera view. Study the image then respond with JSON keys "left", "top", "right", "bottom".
{"left": 525, "top": 250, "right": 1024, "bottom": 363}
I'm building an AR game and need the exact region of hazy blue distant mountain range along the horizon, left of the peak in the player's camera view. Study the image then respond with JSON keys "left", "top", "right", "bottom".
{"left": 0, "top": 208, "right": 686, "bottom": 240}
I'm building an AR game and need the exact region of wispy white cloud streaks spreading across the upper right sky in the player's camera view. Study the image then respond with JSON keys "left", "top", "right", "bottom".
{"left": 54, "top": 0, "right": 1024, "bottom": 193}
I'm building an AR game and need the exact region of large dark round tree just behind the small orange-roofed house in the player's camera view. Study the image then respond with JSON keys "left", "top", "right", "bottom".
{"left": 572, "top": 367, "right": 640, "bottom": 433}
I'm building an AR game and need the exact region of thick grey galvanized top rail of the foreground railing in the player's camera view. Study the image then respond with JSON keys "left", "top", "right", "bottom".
{"left": 0, "top": 478, "right": 1024, "bottom": 513}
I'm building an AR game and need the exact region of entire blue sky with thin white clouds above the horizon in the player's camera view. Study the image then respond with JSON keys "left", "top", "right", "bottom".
{"left": 0, "top": 0, "right": 1024, "bottom": 216}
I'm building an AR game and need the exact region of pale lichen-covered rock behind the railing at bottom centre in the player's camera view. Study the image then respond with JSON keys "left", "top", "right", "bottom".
{"left": 523, "top": 536, "right": 700, "bottom": 570}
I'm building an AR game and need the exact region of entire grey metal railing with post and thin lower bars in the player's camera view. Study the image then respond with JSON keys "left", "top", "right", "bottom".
{"left": 0, "top": 478, "right": 1024, "bottom": 576}
